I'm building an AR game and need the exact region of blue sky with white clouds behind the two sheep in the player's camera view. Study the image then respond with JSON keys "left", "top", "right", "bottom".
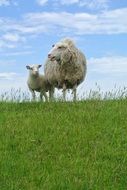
{"left": 0, "top": 0, "right": 127, "bottom": 95}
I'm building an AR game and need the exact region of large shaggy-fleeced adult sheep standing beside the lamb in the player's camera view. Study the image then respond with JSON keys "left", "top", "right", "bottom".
{"left": 44, "top": 39, "right": 87, "bottom": 100}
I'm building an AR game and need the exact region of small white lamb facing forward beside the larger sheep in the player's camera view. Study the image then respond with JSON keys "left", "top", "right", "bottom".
{"left": 26, "top": 65, "right": 48, "bottom": 101}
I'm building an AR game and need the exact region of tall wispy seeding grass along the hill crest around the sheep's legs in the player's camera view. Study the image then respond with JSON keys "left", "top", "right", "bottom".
{"left": 0, "top": 83, "right": 127, "bottom": 102}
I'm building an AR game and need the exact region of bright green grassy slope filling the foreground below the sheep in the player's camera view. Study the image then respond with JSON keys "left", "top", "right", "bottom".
{"left": 0, "top": 100, "right": 127, "bottom": 190}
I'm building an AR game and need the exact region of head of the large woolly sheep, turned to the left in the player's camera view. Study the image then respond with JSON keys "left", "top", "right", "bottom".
{"left": 48, "top": 43, "right": 71, "bottom": 62}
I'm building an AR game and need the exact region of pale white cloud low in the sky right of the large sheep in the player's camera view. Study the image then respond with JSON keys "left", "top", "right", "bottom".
{"left": 78, "top": 56, "right": 127, "bottom": 94}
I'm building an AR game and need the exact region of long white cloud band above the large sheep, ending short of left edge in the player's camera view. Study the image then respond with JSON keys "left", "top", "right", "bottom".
{"left": 24, "top": 8, "right": 127, "bottom": 35}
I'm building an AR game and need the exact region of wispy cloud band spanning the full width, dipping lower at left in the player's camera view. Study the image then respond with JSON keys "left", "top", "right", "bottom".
{"left": 0, "top": 8, "right": 127, "bottom": 48}
